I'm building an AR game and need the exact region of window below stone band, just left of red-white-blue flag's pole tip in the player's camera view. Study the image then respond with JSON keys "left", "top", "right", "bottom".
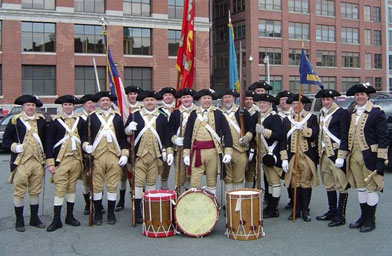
{"left": 74, "top": 25, "right": 104, "bottom": 53}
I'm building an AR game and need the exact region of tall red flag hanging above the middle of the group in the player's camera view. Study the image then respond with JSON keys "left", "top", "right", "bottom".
{"left": 175, "top": 0, "right": 195, "bottom": 90}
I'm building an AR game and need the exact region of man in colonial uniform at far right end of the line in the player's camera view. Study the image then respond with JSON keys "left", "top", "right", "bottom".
{"left": 346, "top": 84, "right": 389, "bottom": 232}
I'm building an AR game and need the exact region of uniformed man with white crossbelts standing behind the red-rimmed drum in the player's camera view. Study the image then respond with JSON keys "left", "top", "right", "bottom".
{"left": 125, "top": 91, "right": 173, "bottom": 223}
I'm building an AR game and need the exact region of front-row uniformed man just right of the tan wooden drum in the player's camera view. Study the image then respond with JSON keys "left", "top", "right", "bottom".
{"left": 256, "top": 94, "right": 283, "bottom": 218}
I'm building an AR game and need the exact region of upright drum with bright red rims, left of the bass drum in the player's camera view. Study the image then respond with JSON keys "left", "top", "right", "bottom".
{"left": 143, "top": 190, "right": 176, "bottom": 238}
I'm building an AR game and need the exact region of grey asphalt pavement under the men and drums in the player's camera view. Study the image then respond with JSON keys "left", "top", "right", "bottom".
{"left": 0, "top": 153, "right": 392, "bottom": 256}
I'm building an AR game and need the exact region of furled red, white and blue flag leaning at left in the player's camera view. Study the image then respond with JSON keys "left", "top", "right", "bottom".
{"left": 104, "top": 32, "right": 129, "bottom": 122}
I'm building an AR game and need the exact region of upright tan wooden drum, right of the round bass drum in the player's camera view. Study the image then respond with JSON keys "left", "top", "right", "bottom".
{"left": 226, "top": 188, "right": 265, "bottom": 240}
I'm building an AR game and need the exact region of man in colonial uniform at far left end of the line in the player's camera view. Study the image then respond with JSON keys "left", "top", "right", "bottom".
{"left": 3, "top": 95, "right": 47, "bottom": 232}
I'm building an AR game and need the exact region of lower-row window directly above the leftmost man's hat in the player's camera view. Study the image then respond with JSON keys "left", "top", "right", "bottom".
{"left": 22, "top": 65, "right": 56, "bottom": 95}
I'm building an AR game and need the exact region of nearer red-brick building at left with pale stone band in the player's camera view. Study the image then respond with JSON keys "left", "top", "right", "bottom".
{"left": 0, "top": 0, "right": 211, "bottom": 104}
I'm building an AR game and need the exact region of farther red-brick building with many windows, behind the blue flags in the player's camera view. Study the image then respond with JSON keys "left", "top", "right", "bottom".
{"left": 212, "top": 0, "right": 386, "bottom": 94}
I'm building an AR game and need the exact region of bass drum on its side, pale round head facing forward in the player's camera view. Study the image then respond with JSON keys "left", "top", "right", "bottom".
{"left": 174, "top": 189, "right": 219, "bottom": 237}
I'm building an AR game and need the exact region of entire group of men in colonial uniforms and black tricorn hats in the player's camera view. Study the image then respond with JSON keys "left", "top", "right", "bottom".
{"left": 4, "top": 81, "right": 389, "bottom": 232}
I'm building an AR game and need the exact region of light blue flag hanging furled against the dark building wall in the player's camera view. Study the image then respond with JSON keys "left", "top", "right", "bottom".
{"left": 227, "top": 13, "right": 240, "bottom": 92}
